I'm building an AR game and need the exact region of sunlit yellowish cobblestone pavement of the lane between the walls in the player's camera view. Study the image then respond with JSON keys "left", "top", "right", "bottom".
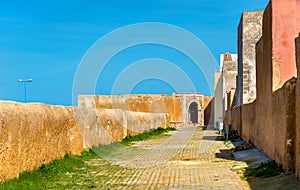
{"left": 89, "top": 126, "right": 250, "bottom": 190}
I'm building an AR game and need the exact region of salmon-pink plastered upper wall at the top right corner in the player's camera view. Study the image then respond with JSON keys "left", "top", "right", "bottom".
{"left": 268, "top": 0, "right": 300, "bottom": 90}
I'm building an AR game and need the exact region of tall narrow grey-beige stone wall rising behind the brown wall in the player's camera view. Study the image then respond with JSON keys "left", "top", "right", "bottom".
{"left": 236, "top": 11, "right": 263, "bottom": 105}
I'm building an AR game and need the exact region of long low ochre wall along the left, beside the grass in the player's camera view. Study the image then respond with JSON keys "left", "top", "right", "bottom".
{"left": 0, "top": 101, "right": 168, "bottom": 181}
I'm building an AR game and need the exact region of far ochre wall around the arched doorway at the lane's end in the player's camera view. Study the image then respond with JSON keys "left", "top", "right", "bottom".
{"left": 78, "top": 93, "right": 204, "bottom": 126}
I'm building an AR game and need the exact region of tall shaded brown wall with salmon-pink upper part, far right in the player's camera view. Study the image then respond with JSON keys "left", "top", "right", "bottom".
{"left": 232, "top": 0, "right": 300, "bottom": 171}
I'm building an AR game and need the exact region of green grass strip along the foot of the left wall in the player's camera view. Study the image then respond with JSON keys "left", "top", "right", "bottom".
{"left": 0, "top": 127, "right": 176, "bottom": 190}
